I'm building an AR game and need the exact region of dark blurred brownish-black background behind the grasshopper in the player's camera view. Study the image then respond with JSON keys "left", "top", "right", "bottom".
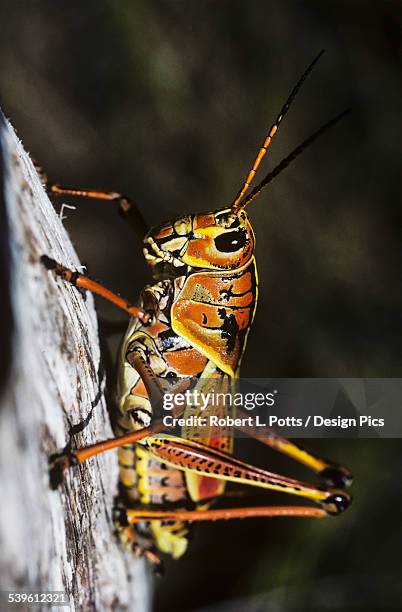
{"left": 0, "top": 0, "right": 402, "bottom": 612}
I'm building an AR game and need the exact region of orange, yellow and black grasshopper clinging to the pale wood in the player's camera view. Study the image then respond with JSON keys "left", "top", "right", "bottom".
{"left": 43, "top": 52, "right": 351, "bottom": 564}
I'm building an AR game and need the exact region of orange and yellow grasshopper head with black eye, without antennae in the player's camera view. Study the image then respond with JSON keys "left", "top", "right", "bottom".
{"left": 144, "top": 208, "right": 255, "bottom": 273}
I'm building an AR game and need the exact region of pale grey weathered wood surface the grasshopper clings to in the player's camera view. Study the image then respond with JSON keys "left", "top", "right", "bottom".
{"left": 0, "top": 112, "right": 149, "bottom": 611}
